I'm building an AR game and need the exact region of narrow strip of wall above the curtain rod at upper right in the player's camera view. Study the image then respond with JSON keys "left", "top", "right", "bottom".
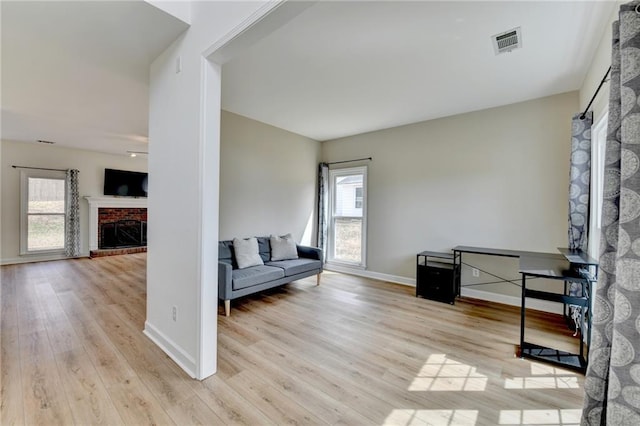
{"left": 580, "top": 1, "right": 626, "bottom": 123}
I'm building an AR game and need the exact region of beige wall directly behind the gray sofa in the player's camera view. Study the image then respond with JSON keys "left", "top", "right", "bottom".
{"left": 219, "top": 111, "right": 320, "bottom": 244}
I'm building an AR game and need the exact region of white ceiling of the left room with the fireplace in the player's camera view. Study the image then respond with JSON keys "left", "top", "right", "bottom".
{"left": 1, "top": 0, "right": 188, "bottom": 154}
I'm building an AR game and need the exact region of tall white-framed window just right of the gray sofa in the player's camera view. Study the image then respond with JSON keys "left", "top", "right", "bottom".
{"left": 328, "top": 167, "right": 367, "bottom": 267}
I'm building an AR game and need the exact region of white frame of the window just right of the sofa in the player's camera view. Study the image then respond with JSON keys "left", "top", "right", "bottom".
{"left": 327, "top": 166, "right": 368, "bottom": 269}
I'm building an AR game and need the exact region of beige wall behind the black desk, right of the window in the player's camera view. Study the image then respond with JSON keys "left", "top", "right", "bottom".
{"left": 322, "top": 92, "right": 578, "bottom": 302}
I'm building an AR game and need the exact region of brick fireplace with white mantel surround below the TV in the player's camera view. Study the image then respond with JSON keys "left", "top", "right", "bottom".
{"left": 85, "top": 197, "right": 147, "bottom": 257}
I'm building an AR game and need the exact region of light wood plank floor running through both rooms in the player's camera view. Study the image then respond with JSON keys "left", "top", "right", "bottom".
{"left": 0, "top": 254, "right": 584, "bottom": 426}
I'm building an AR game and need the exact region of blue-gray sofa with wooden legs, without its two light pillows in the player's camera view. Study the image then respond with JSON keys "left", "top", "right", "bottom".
{"left": 218, "top": 237, "right": 322, "bottom": 316}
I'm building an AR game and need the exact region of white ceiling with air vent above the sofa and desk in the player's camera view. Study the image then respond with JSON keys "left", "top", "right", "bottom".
{"left": 222, "top": 1, "right": 616, "bottom": 140}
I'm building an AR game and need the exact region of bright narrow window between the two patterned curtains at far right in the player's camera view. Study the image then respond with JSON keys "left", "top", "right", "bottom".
{"left": 589, "top": 111, "right": 609, "bottom": 259}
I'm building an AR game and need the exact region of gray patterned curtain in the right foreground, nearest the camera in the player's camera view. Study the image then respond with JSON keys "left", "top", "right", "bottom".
{"left": 582, "top": 1, "right": 640, "bottom": 425}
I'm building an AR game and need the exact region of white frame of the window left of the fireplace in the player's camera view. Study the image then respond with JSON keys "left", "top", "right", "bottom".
{"left": 20, "top": 169, "right": 68, "bottom": 256}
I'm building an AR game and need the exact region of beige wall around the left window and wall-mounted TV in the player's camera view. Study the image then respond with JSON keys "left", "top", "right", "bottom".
{"left": 1, "top": 141, "right": 147, "bottom": 264}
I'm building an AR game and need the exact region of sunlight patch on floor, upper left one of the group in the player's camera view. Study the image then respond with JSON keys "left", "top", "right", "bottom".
{"left": 409, "top": 354, "right": 487, "bottom": 392}
